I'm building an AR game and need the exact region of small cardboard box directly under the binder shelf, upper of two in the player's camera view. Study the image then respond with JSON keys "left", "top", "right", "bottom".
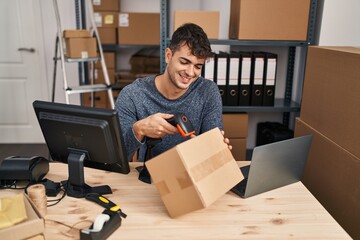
{"left": 223, "top": 113, "right": 248, "bottom": 138}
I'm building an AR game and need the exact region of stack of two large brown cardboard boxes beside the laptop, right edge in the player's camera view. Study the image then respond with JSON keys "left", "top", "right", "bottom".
{"left": 295, "top": 47, "right": 360, "bottom": 239}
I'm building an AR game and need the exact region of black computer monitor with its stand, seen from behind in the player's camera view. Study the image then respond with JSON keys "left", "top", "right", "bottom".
{"left": 33, "top": 101, "right": 130, "bottom": 198}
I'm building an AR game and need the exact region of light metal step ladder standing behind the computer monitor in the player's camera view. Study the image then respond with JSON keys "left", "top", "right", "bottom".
{"left": 52, "top": 0, "right": 114, "bottom": 109}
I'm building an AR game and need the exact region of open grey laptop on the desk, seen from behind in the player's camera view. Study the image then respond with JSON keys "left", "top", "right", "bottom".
{"left": 231, "top": 135, "right": 312, "bottom": 198}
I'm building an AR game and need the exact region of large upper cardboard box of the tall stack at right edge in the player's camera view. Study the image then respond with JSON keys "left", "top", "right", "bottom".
{"left": 300, "top": 47, "right": 360, "bottom": 158}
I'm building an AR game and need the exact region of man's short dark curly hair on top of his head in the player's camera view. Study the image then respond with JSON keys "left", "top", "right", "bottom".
{"left": 169, "top": 23, "right": 211, "bottom": 59}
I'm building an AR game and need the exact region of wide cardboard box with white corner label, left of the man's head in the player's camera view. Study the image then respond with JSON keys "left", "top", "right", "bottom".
{"left": 118, "top": 13, "right": 160, "bottom": 45}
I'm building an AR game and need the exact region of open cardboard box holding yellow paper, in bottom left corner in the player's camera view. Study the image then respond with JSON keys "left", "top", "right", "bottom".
{"left": 0, "top": 192, "right": 45, "bottom": 240}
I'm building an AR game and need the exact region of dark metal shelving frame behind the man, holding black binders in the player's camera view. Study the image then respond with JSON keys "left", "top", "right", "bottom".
{"left": 160, "top": 0, "right": 318, "bottom": 125}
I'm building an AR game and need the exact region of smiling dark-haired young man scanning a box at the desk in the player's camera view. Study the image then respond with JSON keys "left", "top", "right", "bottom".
{"left": 115, "top": 23, "right": 231, "bottom": 161}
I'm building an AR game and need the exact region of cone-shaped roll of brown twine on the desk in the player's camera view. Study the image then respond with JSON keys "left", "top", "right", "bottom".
{"left": 27, "top": 184, "right": 47, "bottom": 217}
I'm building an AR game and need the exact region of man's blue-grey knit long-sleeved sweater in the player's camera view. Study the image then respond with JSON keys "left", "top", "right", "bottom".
{"left": 115, "top": 76, "right": 223, "bottom": 161}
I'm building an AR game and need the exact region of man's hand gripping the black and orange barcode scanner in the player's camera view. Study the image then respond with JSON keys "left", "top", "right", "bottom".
{"left": 133, "top": 113, "right": 178, "bottom": 141}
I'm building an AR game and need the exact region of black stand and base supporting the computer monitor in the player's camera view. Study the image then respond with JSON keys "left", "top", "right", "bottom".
{"left": 61, "top": 149, "right": 112, "bottom": 198}
